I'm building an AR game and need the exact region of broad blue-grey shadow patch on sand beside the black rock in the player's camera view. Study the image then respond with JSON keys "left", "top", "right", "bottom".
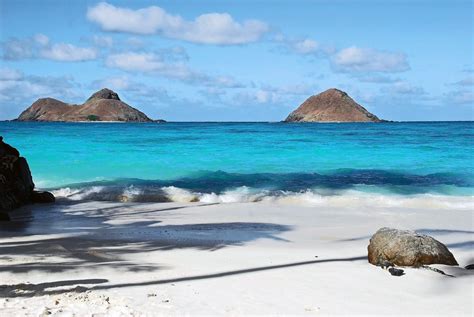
{"left": 0, "top": 203, "right": 291, "bottom": 273}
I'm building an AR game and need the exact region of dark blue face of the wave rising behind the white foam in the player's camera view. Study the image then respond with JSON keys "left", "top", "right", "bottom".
{"left": 47, "top": 169, "right": 474, "bottom": 191}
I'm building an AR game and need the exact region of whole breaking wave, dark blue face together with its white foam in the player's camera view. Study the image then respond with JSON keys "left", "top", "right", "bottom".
{"left": 52, "top": 172, "right": 474, "bottom": 210}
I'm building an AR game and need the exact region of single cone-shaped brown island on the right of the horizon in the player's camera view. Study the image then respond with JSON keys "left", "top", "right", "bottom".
{"left": 285, "top": 88, "right": 383, "bottom": 122}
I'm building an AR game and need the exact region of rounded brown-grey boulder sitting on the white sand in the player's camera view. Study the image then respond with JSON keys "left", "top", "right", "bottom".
{"left": 368, "top": 228, "right": 458, "bottom": 267}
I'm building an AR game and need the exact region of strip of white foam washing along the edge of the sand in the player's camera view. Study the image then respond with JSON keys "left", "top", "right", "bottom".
{"left": 49, "top": 185, "right": 474, "bottom": 210}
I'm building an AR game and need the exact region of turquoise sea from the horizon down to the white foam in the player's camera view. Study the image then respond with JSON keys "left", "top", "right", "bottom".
{"left": 0, "top": 122, "right": 474, "bottom": 200}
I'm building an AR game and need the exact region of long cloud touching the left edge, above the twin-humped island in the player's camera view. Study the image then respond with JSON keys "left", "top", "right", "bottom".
{"left": 2, "top": 34, "right": 98, "bottom": 62}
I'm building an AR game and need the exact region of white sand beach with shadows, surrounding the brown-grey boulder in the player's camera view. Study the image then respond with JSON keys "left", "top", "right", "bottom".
{"left": 0, "top": 202, "right": 474, "bottom": 316}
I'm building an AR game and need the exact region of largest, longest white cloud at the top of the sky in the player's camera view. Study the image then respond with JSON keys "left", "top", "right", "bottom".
{"left": 87, "top": 2, "right": 269, "bottom": 45}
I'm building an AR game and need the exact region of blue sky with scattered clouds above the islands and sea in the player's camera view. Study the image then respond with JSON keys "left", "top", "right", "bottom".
{"left": 0, "top": 0, "right": 474, "bottom": 121}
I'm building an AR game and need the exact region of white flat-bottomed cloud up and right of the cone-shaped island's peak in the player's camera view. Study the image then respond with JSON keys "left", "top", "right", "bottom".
{"left": 331, "top": 46, "right": 410, "bottom": 72}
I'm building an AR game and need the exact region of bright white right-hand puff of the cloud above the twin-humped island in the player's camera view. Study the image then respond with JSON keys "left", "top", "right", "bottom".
{"left": 40, "top": 43, "right": 97, "bottom": 62}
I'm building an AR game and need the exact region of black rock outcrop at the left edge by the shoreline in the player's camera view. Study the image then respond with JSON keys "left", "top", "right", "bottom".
{"left": 0, "top": 136, "right": 54, "bottom": 215}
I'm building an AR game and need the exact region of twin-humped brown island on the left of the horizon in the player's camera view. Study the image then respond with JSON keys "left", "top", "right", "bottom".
{"left": 17, "top": 88, "right": 152, "bottom": 122}
